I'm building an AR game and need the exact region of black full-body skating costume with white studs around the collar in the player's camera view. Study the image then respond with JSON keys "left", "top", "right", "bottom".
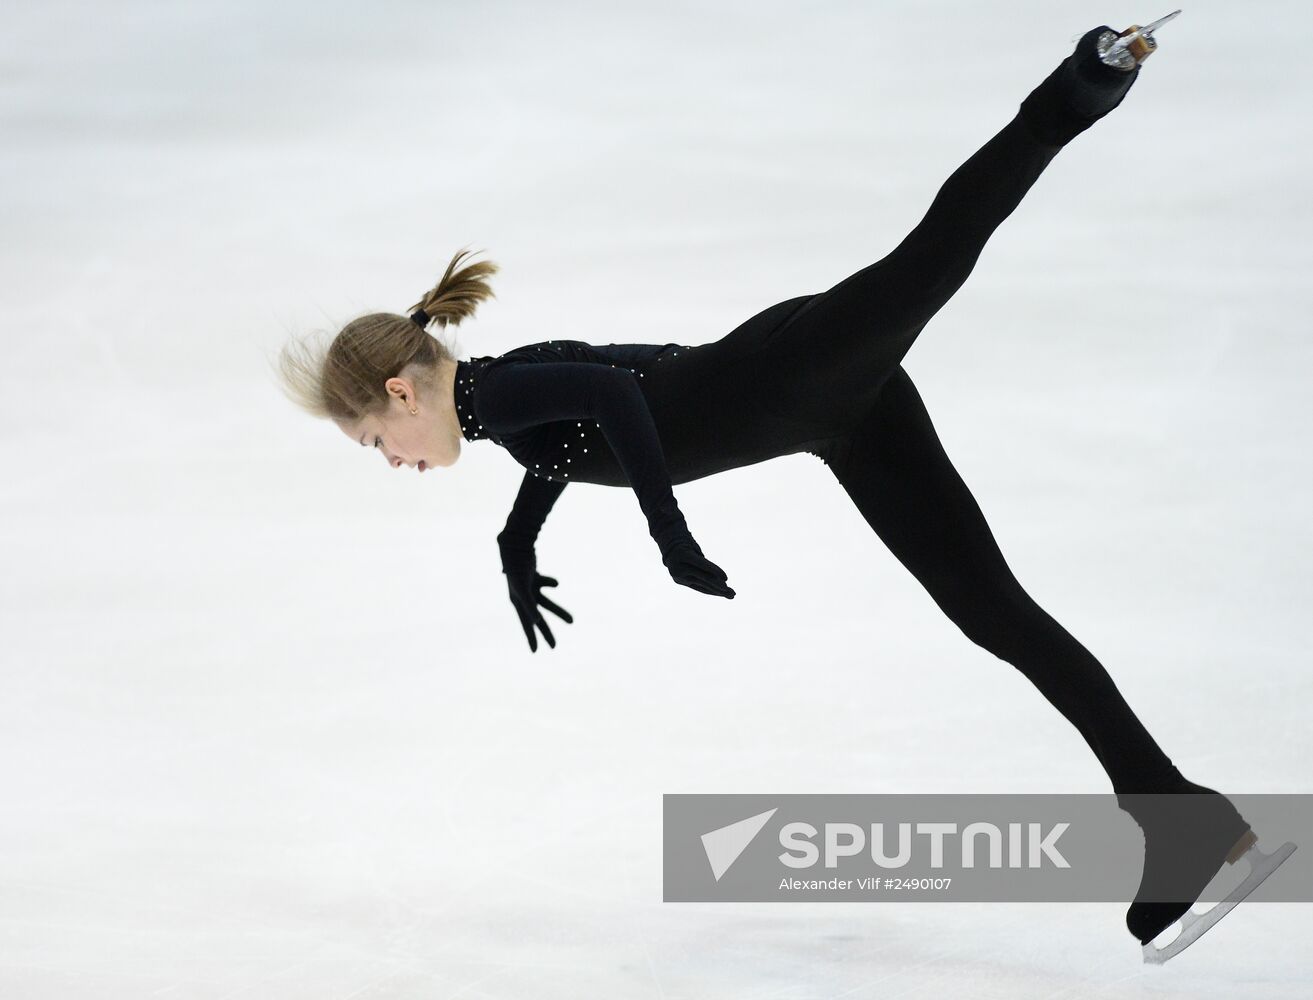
{"left": 454, "top": 29, "right": 1228, "bottom": 834}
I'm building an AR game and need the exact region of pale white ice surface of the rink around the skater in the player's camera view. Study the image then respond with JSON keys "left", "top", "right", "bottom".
{"left": 0, "top": 0, "right": 1313, "bottom": 1000}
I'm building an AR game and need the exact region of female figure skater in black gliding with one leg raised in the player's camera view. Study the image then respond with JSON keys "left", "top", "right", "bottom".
{"left": 281, "top": 26, "right": 1291, "bottom": 960}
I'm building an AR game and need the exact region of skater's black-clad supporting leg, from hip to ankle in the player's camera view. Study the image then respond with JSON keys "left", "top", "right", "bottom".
{"left": 818, "top": 367, "right": 1183, "bottom": 793}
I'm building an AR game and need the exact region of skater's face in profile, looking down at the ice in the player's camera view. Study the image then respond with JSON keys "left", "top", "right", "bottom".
{"left": 337, "top": 375, "right": 462, "bottom": 472}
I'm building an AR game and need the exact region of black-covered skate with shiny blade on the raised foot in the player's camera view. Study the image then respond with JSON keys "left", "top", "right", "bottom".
{"left": 1020, "top": 10, "right": 1180, "bottom": 146}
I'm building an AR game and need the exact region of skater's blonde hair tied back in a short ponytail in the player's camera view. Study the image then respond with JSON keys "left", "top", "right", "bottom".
{"left": 278, "top": 249, "right": 498, "bottom": 421}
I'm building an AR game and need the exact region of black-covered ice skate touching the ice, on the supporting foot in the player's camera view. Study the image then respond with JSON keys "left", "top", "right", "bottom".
{"left": 1121, "top": 782, "right": 1295, "bottom": 965}
